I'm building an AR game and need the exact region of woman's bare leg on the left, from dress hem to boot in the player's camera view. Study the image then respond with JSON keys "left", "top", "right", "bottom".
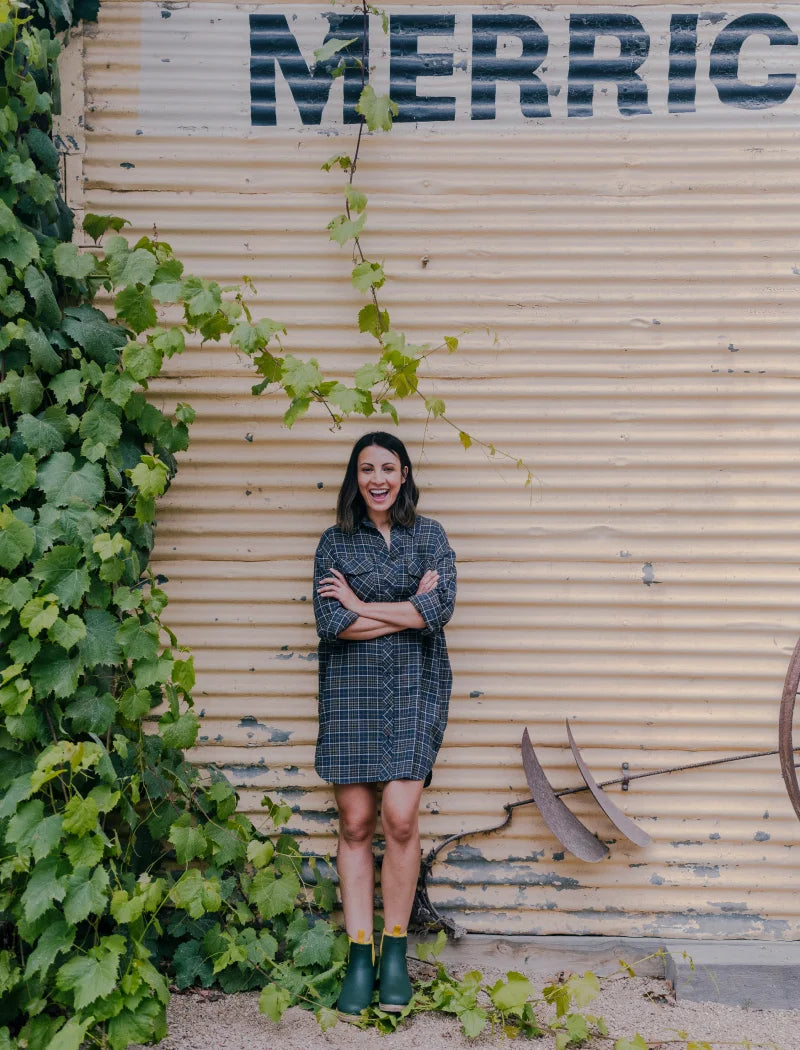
{"left": 334, "top": 784, "right": 378, "bottom": 941}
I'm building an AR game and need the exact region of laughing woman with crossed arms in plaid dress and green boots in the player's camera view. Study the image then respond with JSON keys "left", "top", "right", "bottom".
{"left": 314, "top": 432, "right": 456, "bottom": 1019}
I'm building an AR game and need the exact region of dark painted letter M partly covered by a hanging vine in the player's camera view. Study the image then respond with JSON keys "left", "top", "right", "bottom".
{"left": 250, "top": 14, "right": 369, "bottom": 127}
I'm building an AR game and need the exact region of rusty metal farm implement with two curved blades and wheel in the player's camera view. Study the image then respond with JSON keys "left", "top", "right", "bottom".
{"left": 412, "top": 641, "right": 800, "bottom": 940}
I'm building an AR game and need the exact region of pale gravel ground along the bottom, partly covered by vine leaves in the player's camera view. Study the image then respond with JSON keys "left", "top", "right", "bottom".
{"left": 137, "top": 968, "right": 800, "bottom": 1050}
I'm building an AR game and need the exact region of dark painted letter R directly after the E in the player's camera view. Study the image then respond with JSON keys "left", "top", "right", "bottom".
{"left": 472, "top": 15, "right": 550, "bottom": 121}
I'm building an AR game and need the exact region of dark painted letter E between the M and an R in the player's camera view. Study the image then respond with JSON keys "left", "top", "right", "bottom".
{"left": 388, "top": 15, "right": 456, "bottom": 122}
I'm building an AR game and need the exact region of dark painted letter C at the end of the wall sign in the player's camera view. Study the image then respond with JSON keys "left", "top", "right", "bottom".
{"left": 709, "top": 15, "right": 797, "bottom": 109}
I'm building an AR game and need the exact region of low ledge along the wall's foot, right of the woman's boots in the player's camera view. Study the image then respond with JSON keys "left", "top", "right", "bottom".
{"left": 409, "top": 933, "right": 800, "bottom": 1010}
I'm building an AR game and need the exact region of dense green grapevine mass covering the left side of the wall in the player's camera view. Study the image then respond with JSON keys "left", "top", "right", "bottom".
{"left": 0, "top": 0, "right": 377, "bottom": 1050}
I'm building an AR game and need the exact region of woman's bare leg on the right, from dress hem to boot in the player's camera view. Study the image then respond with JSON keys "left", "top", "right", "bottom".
{"left": 381, "top": 780, "right": 422, "bottom": 933}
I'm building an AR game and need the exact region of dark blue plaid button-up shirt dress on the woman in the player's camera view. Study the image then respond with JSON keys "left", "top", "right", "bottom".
{"left": 314, "top": 516, "right": 456, "bottom": 784}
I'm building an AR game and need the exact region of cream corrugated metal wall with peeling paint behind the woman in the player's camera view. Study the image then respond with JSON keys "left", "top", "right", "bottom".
{"left": 68, "top": 0, "right": 800, "bottom": 939}
